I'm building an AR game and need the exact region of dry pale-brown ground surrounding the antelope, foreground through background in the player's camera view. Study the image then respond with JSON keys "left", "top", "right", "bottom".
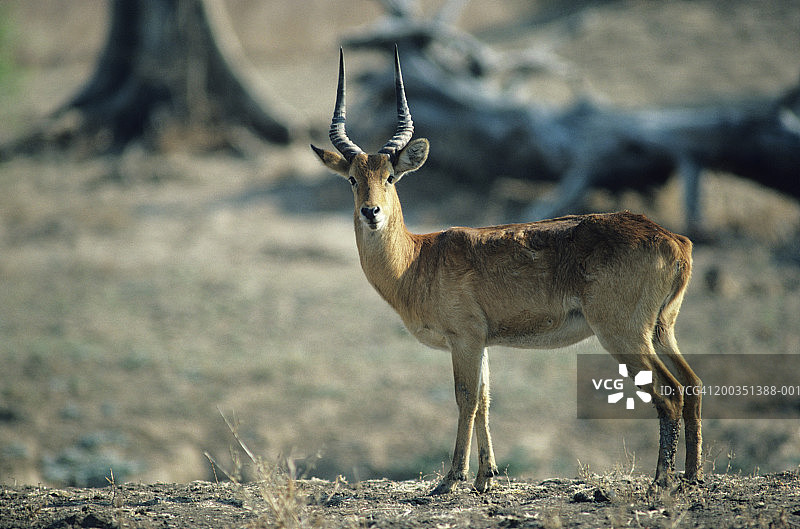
{"left": 0, "top": 1, "right": 800, "bottom": 527}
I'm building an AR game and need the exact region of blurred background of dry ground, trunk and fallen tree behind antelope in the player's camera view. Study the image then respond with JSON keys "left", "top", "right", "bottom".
{"left": 0, "top": 0, "right": 800, "bottom": 486}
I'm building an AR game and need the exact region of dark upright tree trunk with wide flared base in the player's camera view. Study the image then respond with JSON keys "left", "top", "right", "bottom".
{"left": 2, "top": 0, "right": 303, "bottom": 153}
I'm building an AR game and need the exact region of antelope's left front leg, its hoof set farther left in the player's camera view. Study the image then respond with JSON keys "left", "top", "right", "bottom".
{"left": 431, "top": 347, "right": 484, "bottom": 494}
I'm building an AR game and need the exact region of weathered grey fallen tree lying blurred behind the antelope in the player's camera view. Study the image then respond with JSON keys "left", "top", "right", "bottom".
{"left": 348, "top": 1, "right": 800, "bottom": 229}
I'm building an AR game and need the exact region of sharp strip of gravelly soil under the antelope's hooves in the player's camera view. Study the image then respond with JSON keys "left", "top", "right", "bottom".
{"left": 0, "top": 472, "right": 800, "bottom": 529}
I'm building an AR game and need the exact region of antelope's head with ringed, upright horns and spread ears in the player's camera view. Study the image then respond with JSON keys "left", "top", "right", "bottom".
{"left": 311, "top": 47, "right": 428, "bottom": 231}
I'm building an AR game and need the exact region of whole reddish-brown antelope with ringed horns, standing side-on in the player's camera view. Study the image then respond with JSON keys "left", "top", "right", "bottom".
{"left": 311, "top": 50, "right": 702, "bottom": 494}
